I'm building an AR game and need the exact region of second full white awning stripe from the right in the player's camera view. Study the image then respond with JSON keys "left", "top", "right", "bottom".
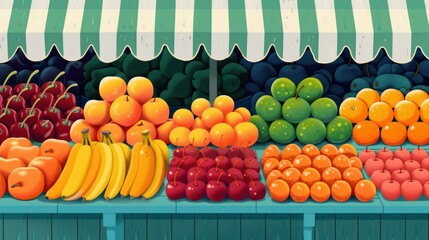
{"left": 352, "top": 0, "right": 374, "bottom": 62}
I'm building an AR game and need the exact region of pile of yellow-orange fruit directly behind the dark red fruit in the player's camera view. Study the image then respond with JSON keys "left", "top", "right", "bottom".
{"left": 163, "top": 95, "right": 258, "bottom": 147}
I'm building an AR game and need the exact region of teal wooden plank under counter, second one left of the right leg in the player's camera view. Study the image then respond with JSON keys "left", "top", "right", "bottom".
{"left": 265, "top": 214, "right": 291, "bottom": 240}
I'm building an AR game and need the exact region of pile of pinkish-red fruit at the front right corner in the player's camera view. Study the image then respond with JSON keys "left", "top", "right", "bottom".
{"left": 359, "top": 147, "right": 429, "bottom": 201}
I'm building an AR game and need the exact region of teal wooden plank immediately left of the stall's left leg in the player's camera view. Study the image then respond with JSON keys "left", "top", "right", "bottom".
{"left": 77, "top": 214, "right": 102, "bottom": 239}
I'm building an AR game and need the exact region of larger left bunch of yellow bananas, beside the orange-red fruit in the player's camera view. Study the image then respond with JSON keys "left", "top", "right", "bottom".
{"left": 46, "top": 129, "right": 131, "bottom": 201}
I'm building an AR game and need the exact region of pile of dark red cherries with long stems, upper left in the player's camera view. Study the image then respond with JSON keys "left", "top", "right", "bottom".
{"left": 0, "top": 70, "right": 83, "bottom": 143}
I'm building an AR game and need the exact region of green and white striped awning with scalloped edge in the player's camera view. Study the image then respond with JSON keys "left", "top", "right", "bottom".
{"left": 0, "top": 0, "right": 429, "bottom": 63}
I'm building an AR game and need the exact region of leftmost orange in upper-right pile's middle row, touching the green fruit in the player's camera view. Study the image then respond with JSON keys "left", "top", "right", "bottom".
{"left": 339, "top": 98, "right": 368, "bottom": 123}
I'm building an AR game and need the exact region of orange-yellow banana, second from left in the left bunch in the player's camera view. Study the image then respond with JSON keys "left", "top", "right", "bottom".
{"left": 64, "top": 142, "right": 101, "bottom": 201}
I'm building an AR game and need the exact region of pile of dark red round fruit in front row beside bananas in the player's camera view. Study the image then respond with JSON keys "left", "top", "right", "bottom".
{"left": 165, "top": 146, "right": 266, "bottom": 202}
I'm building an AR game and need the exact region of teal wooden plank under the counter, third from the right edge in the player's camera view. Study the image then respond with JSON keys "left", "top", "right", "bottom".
{"left": 358, "top": 214, "right": 381, "bottom": 240}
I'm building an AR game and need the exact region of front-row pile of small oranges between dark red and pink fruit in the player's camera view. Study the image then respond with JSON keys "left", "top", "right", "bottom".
{"left": 262, "top": 144, "right": 376, "bottom": 202}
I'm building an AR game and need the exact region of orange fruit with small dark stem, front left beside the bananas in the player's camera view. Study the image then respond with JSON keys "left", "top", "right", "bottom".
{"left": 8, "top": 167, "right": 45, "bottom": 200}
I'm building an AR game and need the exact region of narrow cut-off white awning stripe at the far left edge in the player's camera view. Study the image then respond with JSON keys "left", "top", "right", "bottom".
{"left": 0, "top": 0, "right": 13, "bottom": 62}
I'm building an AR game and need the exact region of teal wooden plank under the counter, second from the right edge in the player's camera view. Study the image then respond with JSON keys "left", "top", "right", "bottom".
{"left": 380, "top": 214, "right": 406, "bottom": 240}
